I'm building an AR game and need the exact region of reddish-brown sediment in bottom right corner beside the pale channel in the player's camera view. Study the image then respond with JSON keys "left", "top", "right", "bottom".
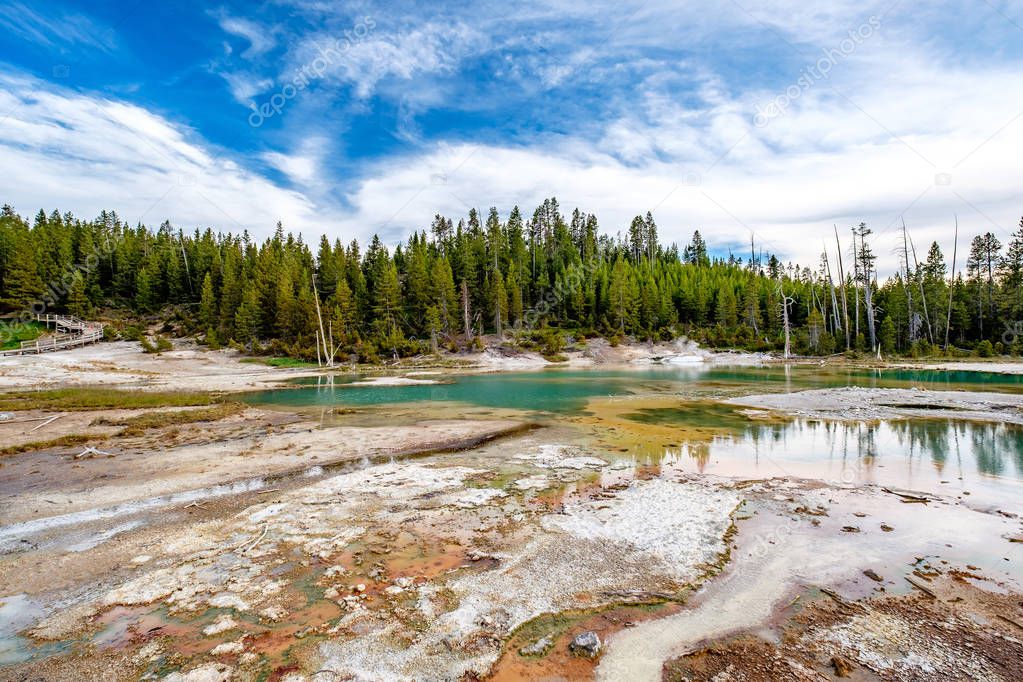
{"left": 663, "top": 570, "right": 1023, "bottom": 682}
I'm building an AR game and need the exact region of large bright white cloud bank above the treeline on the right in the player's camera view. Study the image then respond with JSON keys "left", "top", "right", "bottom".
{"left": 333, "top": 34, "right": 1023, "bottom": 272}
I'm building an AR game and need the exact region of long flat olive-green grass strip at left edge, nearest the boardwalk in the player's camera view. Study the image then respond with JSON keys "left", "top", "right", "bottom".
{"left": 0, "top": 389, "right": 222, "bottom": 411}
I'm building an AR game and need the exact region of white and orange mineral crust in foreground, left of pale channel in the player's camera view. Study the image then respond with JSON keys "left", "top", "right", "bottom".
{"left": 4, "top": 437, "right": 739, "bottom": 680}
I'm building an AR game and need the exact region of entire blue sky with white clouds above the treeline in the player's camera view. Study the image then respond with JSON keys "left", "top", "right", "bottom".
{"left": 0, "top": 0, "right": 1023, "bottom": 269}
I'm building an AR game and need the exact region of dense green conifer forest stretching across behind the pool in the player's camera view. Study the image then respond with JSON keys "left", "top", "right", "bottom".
{"left": 0, "top": 198, "right": 1023, "bottom": 362}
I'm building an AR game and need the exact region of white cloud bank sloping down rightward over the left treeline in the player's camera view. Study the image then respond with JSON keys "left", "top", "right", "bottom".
{"left": 0, "top": 75, "right": 329, "bottom": 235}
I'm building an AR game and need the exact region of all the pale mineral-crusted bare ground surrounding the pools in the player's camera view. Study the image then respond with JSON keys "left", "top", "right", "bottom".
{"left": 0, "top": 343, "right": 1023, "bottom": 682}
